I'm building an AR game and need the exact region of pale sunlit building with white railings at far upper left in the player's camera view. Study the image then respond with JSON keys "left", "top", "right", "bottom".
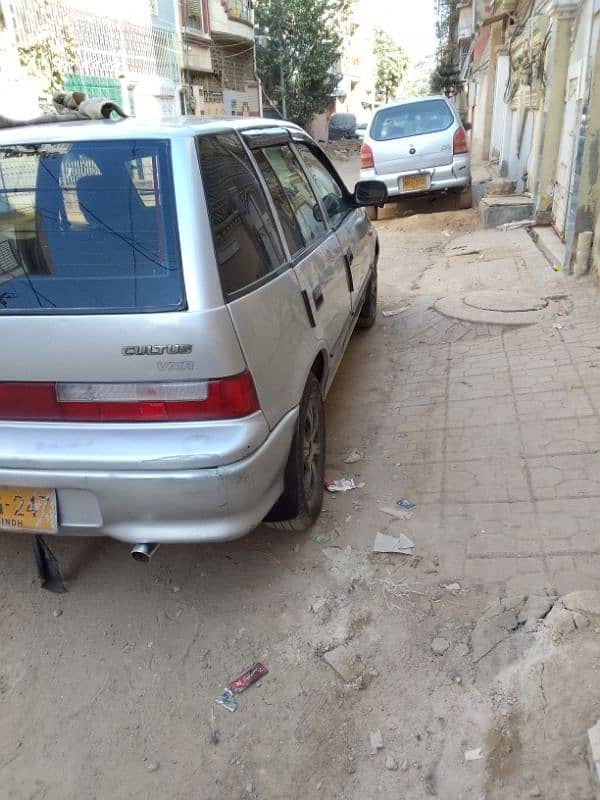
{"left": 5, "top": 0, "right": 180, "bottom": 116}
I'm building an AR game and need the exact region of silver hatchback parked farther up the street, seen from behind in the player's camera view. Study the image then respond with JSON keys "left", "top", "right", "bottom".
{"left": 360, "top": 95, "right": 471, "bottom": 216}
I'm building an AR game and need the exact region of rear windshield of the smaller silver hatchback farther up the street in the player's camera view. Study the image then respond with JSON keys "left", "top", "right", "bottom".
{"left": 370, "top": 100, "right": 454, "bottom": 142}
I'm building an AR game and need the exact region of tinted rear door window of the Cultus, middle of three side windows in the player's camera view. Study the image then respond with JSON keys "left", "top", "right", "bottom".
{"left": 254, "top": 145, "right": 326, "bottom": 255}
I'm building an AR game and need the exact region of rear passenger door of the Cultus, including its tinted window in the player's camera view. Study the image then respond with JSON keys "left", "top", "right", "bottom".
{"left": 252, "top": 140, "right": 351, "bottom": 369}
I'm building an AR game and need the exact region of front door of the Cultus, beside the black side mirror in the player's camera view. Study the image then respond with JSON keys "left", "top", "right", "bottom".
{"left": 294, "top": 139, "right": 375, "bottom": 314}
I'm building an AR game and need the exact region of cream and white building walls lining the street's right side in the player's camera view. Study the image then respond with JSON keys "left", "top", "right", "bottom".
{"left": 464, "top": 0, "right": 600, "bottom": 274}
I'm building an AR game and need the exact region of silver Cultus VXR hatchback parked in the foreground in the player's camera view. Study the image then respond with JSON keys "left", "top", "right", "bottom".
{"left": 0, "top": 119, "right": 386, "bottom": 551}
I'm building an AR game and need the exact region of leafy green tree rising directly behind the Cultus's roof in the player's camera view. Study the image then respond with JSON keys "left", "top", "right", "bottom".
{"left": 255, "top": 0, "right": 349, "bottom": 127}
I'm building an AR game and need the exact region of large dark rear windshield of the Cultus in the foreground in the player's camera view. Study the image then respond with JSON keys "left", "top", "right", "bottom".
{"left": 0, "top": 139, "right": 183, "bottom": 315}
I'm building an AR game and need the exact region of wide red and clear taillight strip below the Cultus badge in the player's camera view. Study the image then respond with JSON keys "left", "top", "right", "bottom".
{"left": 0, "top": 372, "right": 259, "bottom": 422}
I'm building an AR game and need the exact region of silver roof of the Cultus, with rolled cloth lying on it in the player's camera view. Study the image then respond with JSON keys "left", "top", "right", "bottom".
{"left": 0, "top": 117, "right": 302, "bottom": 145}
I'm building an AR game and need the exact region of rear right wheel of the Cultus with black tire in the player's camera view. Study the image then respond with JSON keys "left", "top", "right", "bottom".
{"left": 265, "top": 373, "right": 325, "bottom": 531}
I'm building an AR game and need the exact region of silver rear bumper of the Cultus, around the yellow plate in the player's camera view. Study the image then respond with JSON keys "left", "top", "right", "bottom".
{"left": 0, "top": 408, "right": 298, "bottom": 543}
